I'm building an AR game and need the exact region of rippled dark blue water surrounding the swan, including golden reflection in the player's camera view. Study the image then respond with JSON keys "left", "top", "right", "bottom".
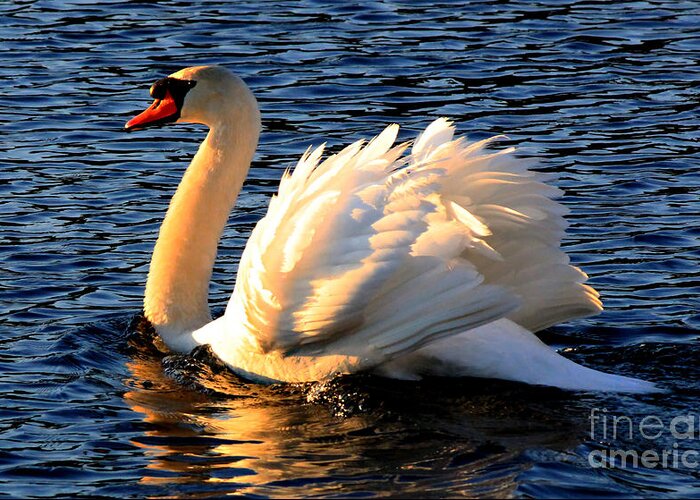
{"left": 0, "top": 0, "right": 700, "bottom": 498}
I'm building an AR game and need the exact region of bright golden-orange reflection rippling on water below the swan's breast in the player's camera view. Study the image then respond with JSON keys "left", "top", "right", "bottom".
{"left": 124, "top": 359, "right": 382, "bottom": 493}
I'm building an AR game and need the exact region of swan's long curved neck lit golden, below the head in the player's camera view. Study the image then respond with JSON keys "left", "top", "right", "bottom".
{"left": 144, "top": 114, "right": 260, "bottom": 352}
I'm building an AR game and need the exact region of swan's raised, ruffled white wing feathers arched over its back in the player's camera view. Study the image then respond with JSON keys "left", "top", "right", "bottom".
{"left": 226, "top": 119, "right": 597, "bottom": 365}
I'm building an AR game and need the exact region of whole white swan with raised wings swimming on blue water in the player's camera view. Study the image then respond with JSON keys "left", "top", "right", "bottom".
{"left": 126, "top": 66, "right": 655, "bottom": 392}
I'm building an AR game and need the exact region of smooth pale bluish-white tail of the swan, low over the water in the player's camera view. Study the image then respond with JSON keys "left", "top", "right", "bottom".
{"left": 380, "top": 319, "right": 661, "bottom": 393}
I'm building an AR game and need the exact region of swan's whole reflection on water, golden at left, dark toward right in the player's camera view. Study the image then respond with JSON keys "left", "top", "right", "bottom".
{"left": 125, "top": 342, "right": 587, "bottom": 496}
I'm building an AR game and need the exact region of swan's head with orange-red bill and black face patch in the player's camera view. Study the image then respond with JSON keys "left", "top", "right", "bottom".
{"left": 124, "top": 66, "right": 260, "bottom": 130}
